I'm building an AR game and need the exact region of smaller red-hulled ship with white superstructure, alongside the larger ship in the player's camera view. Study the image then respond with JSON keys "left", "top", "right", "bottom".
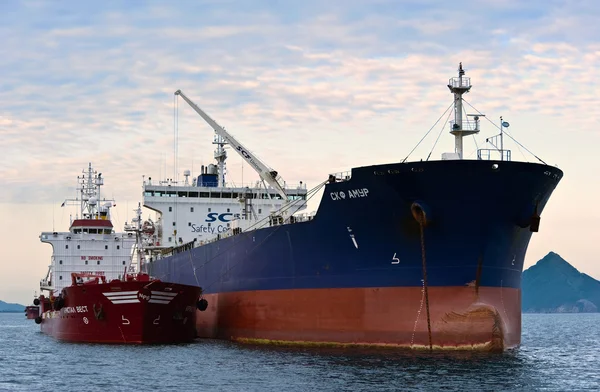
{"left": 35, "top": 164, "right": 207, "bottom": 344}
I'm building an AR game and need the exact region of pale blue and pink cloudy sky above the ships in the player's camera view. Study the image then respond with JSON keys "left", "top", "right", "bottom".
{"left": 0, "top": 0, "right": 600, "bottom": 304}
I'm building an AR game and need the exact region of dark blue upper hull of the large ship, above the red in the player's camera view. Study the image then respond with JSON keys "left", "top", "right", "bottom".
{"left": 150, "top": 160, "right": 562, "bottom": 350}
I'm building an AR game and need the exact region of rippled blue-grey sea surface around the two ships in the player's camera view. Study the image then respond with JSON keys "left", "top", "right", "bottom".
{"left": 0, "top": 313, "right": 600, "bottom": 391}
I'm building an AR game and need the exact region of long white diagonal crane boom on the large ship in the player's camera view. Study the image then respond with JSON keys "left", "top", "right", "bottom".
{"left": 175, "top": 90, "right": 288, "bottom": 201}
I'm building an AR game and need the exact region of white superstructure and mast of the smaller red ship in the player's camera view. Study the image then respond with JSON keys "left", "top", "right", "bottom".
{"left": 40, "top": 163, "right": 136, "bottom": 294}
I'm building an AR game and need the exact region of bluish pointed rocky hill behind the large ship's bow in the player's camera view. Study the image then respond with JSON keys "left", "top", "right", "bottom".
{"left": 522, "top": 252, "right": 600, "bottom": 313}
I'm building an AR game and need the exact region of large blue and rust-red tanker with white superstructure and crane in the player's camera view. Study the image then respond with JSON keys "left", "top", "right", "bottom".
{"left": 143, "top": 64, "right": 563, "bottom": 350}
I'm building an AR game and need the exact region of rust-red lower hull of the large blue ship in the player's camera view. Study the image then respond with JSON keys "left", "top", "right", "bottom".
{"left": 196, "top": 287, "right": 521, "bottom": 351}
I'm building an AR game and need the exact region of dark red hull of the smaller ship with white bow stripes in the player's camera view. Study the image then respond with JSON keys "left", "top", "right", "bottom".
{"left": 41, "top": 281, "right": 201, "bottom": 344}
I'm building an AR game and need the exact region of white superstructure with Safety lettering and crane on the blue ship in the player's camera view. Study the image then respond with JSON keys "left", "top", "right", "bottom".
{"left": 143, "top": 90, "right": 310, "bottom": 248}
